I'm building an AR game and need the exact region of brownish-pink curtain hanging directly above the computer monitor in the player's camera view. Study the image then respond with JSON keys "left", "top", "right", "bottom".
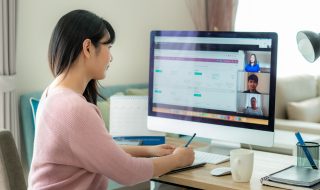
{"left": 186, "top": 0, "right": 238, "bottom": 31}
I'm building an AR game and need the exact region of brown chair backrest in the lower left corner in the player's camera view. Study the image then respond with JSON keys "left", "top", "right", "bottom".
{"left": 0, "top": 130, "right": 27, "bottom": 190}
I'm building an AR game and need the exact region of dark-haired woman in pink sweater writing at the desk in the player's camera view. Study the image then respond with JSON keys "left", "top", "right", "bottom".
{"left": 28, "top": 10, "right": 194, "bottom": 190}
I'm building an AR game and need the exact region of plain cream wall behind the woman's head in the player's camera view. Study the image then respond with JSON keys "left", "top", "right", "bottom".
{"left": 17, "top": 0, "right": 195, "bottom": 94}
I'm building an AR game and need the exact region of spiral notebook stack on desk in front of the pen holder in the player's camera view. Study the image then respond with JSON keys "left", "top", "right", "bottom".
{"left": 261, "top": 166, "right": 320, "bottom": 190}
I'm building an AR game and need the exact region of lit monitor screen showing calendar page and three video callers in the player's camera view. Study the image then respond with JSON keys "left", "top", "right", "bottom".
{"left": 153, "top": 36, "right": 271, "bottom": 125}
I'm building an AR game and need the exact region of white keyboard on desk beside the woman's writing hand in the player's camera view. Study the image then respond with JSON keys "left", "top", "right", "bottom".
{"left": 194, "top": 150, "right": 230, "bottom": 164}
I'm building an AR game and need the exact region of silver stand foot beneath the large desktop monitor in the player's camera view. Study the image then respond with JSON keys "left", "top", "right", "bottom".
{"left": 197, "top": 140, "right": 240, "bottom": 156}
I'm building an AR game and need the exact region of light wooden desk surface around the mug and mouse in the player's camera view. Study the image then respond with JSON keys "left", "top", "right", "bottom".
{"left": 156, "top": 138, "right": 296, "bottom": 190}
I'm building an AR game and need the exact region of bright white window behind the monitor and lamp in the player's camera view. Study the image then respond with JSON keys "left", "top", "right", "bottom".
{"left": 235, "top": 0, "right": 320, "bottom": 76}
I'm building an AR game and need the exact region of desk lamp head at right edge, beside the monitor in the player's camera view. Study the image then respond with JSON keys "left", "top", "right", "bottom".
{"left": 297, "top": 31, "right": 320, "bottom": 63}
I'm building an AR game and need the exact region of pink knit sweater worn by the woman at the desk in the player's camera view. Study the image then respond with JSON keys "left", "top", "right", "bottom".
{"left": 28, "top": 88, "right": 153, "bottom": 190}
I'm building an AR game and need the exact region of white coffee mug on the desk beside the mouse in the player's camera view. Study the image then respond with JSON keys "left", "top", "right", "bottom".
{"left": 230, "top": 149, "right": 253, "bottom": 182}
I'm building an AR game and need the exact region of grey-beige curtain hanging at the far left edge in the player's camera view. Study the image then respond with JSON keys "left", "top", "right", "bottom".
{"left": 0, "top": 0, "right": 20, "bottom": 152}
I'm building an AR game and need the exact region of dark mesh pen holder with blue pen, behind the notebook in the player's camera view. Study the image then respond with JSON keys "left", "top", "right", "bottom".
{"left": 297, "top": 142, "right": 319, "bottom": 168}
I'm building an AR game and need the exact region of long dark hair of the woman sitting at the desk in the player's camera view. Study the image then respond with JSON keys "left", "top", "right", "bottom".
{"left": 48, "top": 10, "right": 115, "bottom": 104}
